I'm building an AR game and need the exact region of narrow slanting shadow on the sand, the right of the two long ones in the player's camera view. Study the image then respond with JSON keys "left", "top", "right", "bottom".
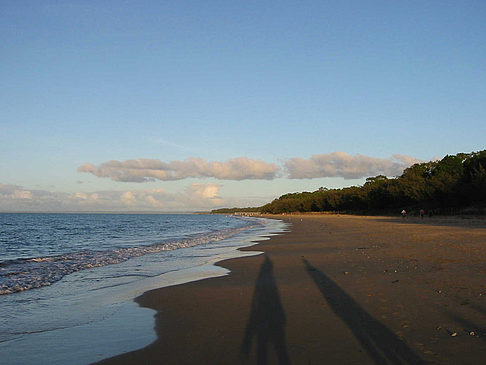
{"left": 303, "top": 259, "right": 426, "bottom": 364}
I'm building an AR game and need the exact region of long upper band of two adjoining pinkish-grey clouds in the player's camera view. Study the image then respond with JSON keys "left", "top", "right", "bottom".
{"left": 78, "top": 152, "right": 421, "bottom": 182}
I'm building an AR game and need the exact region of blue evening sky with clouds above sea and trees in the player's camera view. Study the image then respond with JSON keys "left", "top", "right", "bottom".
{"left": 0, "top": 0, "right": 486, "bottom": 212}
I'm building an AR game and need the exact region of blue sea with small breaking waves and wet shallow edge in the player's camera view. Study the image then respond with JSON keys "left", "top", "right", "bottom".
{"left": 0, "top": 213, "right": 285, "bottom": 364}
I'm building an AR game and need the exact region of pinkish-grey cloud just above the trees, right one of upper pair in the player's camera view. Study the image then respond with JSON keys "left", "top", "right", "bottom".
{"left": 285, "top": 152, "right": 421, "bottom": 179}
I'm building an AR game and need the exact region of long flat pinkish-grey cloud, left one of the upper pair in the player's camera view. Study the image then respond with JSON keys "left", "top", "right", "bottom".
{"left": 78, "top": 157, "right": 280, "bottom": 182}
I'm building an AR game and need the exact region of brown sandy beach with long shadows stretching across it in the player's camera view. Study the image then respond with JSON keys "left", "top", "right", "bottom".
{"left": 95, "top": 215, "right": 486, "bottom": 365}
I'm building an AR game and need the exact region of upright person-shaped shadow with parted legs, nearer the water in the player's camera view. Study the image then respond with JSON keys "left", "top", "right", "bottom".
{"left": 241, "top": 256, "right": 290, "bottom": 365}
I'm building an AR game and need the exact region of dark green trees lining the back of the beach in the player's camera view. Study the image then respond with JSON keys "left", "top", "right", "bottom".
{"left": 256, "top": 150, "right": 486, "bottom": 213}
